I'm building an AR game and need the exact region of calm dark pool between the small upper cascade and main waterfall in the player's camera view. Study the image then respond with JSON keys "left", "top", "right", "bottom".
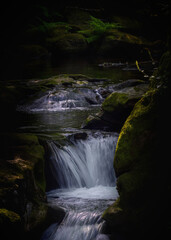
{"left": 18, "top": 106, "right": 99, "bottom": 134}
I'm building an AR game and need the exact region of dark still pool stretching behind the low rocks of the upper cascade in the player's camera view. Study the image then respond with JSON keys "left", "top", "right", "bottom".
{"left": 4, "top": 56, "right": 141, "bottom": 81}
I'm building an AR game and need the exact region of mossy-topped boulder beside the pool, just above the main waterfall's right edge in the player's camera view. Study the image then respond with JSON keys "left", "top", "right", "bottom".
{"left": 83, "top": 80, "right": 148, "bottom": 131}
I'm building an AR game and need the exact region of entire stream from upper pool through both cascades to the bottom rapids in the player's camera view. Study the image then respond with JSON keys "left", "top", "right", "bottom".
{"left": 15, "top": 58, "right": 148, "bottom": 240}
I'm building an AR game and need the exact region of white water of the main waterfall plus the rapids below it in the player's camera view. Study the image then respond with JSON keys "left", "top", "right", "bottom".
{"left": 42, "top": 133, "right": 118, "bottom": 240}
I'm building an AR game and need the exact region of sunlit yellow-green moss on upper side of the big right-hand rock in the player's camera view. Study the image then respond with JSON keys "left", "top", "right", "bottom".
{"left": 115, "top": 90, "right": 157, "bottom": 175}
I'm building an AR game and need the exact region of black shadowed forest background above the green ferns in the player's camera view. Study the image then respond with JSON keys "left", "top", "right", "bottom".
{"left": 0, "top": 0, "right": 170, "bottom": 78}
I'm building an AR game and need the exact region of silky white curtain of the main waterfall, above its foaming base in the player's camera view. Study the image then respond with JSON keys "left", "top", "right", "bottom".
{"left": 45, "top": 133, "right": 117, "bottom": 188}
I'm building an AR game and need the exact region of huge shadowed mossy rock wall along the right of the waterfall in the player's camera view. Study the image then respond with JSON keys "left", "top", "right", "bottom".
{"left": 103, "top": 52, "right": 171, "bottom": 239}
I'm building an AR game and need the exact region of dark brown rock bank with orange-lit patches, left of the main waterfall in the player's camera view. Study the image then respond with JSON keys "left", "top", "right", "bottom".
{"left": 0, "top": 133, "right": 47, "bottom": 239}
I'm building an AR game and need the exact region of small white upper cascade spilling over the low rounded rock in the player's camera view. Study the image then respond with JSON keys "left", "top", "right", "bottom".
{"left": 17, "top": 88, "right": 104, "bottom": 112}
